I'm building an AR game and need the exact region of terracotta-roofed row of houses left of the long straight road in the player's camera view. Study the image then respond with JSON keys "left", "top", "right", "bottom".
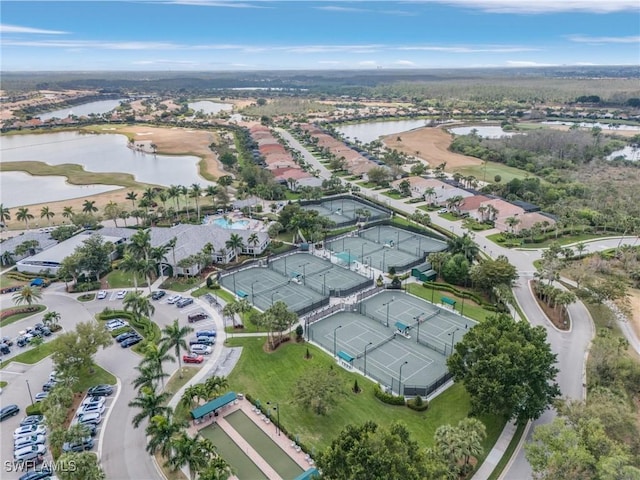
{"left": 249, "top": 125, "right": 322, "bottom": 190}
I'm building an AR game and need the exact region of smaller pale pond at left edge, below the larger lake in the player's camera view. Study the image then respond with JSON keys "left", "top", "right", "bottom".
{"left": 0, "top": 172, "right": 122, "bottom": 208}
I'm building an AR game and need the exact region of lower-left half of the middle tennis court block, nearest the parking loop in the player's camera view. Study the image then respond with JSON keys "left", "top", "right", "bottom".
{"left": 220, "top": 262, "right": 329, "bottom": 315}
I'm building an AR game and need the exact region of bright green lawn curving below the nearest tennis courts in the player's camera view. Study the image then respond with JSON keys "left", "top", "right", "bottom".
{"left": 229, "top": 337, "right": 505, "bottom": 460}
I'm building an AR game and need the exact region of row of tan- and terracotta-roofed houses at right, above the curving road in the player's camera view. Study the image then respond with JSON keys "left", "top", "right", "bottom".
{"left": 391, "top": 177, "right": 556, "bottom": 232}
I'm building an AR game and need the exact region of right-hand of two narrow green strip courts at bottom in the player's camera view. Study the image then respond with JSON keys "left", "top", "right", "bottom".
{"left": 224, "top": 410, "right": 304, "bottom": 478}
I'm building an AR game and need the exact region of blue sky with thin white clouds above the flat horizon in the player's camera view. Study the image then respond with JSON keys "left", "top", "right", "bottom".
{"left": 0, "top": 0, "right": 640, "bottom": 71}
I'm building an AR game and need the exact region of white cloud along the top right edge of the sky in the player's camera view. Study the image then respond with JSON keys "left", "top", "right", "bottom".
{"left": 416, "top": 0, "right": 640, "bottom": 14}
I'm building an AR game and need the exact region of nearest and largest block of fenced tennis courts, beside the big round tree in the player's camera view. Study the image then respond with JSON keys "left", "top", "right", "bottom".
{"left": 309, "top": 291, "right": 475, "bottom": 394}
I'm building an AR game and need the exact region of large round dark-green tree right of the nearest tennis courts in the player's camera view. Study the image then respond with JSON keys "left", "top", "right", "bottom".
{"left": 447, "top": 314, "right": 560, "bottom": 422}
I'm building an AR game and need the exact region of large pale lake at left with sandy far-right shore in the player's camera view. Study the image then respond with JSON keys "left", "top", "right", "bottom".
{"left": 0, "top": 132, "right": 215, "bottom": 204}
